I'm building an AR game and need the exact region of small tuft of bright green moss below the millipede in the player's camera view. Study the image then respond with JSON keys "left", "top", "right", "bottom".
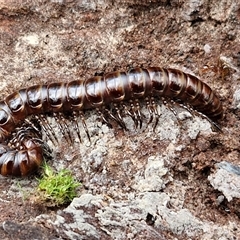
{"left": 38, "top": 164, "right": 80, "bottom": 206}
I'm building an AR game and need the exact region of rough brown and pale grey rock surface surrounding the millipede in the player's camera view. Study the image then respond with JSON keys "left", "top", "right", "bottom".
{"left": 0, "top": 0, "right": 240, "bottom": 239}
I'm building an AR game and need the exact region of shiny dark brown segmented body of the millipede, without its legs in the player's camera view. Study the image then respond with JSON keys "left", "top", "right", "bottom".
{"left": 0, "top": 67, "right": 223, "bottom": 176}
